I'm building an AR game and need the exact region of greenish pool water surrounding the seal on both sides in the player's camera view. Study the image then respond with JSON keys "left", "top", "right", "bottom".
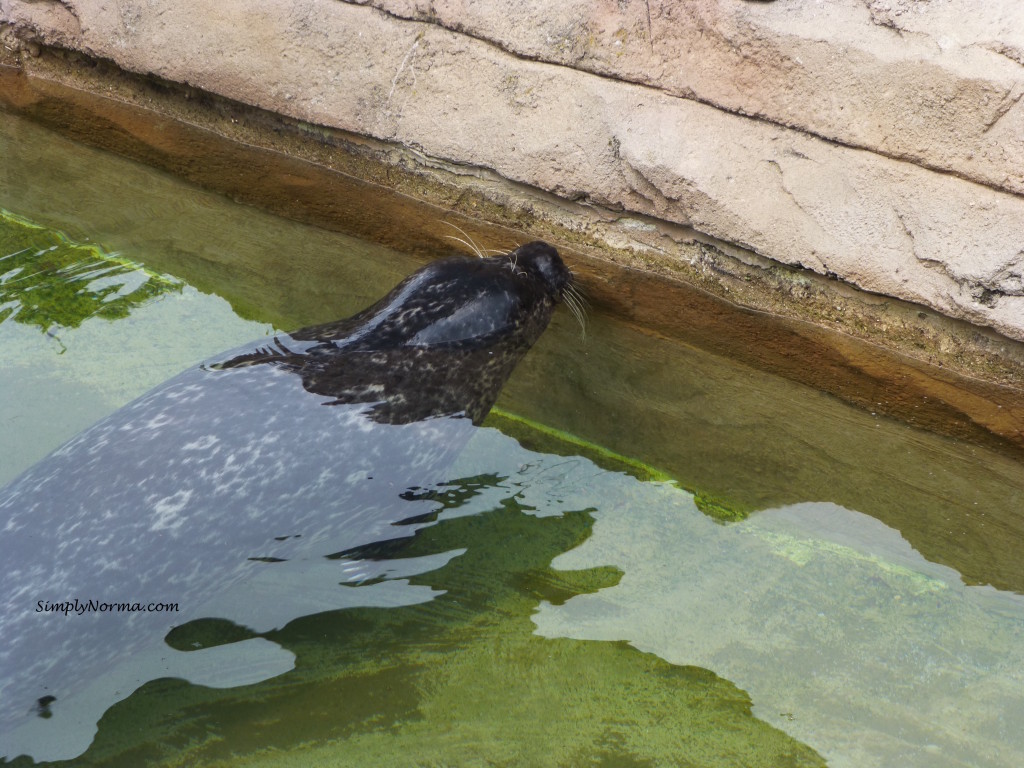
{"left": 0, "top": 103, "right": 1024, "bottom": 766}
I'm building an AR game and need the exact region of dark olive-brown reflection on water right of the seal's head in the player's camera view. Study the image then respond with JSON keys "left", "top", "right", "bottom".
{"left": 500, "top": 315, "right": 1024, "bottom": 593}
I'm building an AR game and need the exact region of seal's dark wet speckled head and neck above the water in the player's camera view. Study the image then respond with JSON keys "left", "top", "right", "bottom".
{"left": 218, "top": 242, "right": 572, "bottom": 424}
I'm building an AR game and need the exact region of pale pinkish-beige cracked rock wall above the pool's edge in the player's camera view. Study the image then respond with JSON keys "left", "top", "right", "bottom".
{"left": 0, "top": 0, "right": 1024, "bottom": 341}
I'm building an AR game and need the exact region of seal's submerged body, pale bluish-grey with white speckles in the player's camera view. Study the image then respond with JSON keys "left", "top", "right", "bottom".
{"left": 0, "top": 360, "right": 472, "bottom": 759}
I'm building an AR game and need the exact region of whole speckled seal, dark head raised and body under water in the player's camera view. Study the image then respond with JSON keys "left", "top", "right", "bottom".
{"left": 0, "top": 243, "right": 572, "bottom": 761}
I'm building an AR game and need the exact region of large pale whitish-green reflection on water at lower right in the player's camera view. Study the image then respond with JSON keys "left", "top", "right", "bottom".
{"left": 536, "top": 488, "right": 1024, "bottom": 768}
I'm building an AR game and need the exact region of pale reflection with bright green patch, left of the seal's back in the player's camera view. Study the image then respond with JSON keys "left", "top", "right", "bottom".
{"left": 0, "top": 209, "right": 270, "bottom": 486}
